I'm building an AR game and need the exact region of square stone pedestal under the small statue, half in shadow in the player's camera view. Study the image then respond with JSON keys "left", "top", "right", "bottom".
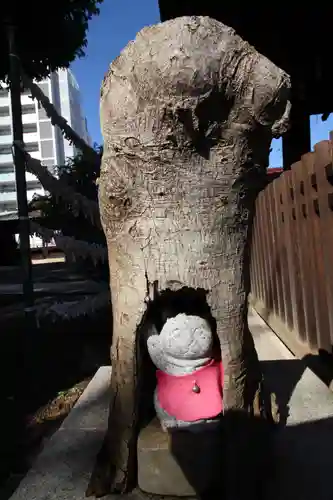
{"left": 138, "top": 419, "right": 222, "bottom": 497}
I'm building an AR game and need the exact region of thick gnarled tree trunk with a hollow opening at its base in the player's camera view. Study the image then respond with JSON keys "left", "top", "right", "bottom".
{"left": 89, "top": 17, "right": 290, "bottom": 494}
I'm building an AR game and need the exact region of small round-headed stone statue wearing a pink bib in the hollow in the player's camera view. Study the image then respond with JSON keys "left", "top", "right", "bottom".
{"left": 147, "top": 314, "right": 223, "bottom": 430}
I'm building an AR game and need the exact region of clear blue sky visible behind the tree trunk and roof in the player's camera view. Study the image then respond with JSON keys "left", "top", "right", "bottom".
{"left": 72, "top": 0, "right": 333, "bottom": 167}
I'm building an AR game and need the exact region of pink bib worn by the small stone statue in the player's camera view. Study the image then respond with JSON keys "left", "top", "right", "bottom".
{"left": 156, "top": 360, "right": 223, "bottom": 422}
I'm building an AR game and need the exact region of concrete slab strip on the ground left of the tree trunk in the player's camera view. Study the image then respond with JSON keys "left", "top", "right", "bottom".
{"left": 7, "top": 366, "right": 111, "bottom": 500}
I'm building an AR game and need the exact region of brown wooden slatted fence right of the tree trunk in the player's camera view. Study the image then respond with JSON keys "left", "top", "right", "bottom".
{"left": 250, "top": 133, "right": 333, "bottom": 353}
